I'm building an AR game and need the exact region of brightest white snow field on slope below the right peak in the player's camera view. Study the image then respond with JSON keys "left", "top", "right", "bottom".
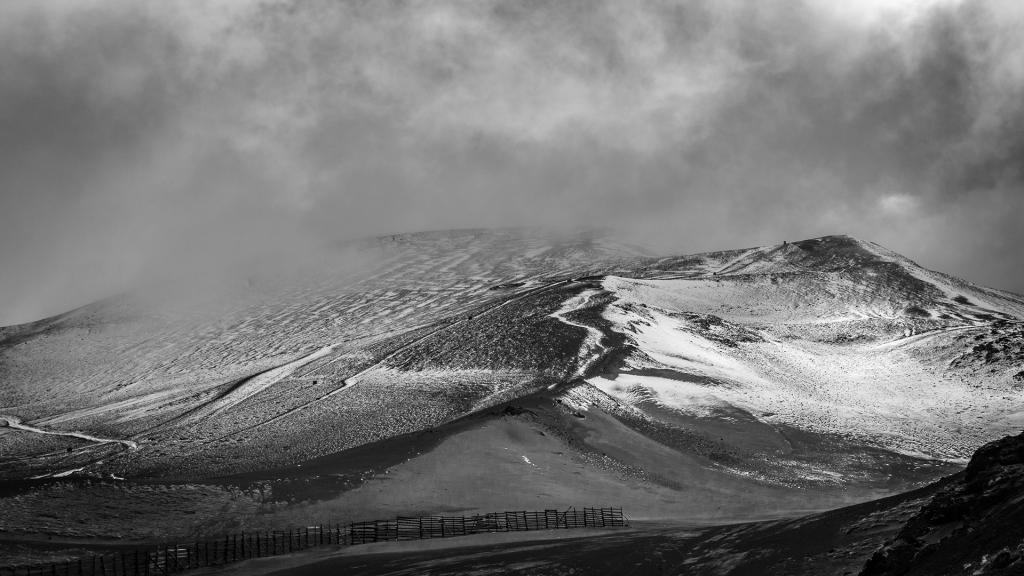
{"left": 589, "top": 277, "right": 1019, "bottom": 459}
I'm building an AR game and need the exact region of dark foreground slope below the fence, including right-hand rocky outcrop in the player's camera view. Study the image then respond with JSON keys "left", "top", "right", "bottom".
{"left": 205, "top": 434, "right": 1024, "bottom": 576}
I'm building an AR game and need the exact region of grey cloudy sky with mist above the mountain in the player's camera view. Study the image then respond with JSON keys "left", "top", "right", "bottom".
{"left": 0, "top": 0, "right": 1024, "bottom": 325}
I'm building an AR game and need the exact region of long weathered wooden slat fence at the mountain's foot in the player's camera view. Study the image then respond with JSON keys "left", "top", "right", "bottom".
{"left": 0, "top": 508, "right": 628, "bottom": 576}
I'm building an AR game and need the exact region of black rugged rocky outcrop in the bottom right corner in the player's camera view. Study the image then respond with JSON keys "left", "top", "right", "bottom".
{"left": 861, "top": 434, "right": 1024, "bottom": 576}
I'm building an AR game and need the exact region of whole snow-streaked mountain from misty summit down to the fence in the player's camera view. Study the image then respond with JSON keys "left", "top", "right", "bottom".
{"left": 0, "top": 231, "right": 1024, "bottom": 565}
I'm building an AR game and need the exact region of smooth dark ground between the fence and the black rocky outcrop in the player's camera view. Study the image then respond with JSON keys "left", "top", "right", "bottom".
{"left": 207, "top": 475, "right": 941, "bottom": 576}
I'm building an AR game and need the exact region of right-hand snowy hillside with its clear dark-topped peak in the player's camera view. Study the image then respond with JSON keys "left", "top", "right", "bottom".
{"left": 590, "top": 237, "right": 1024, "bottom": 461}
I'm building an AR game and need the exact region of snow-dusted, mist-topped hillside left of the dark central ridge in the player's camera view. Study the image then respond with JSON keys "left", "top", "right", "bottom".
{"left": 0, "top": 230, "right": 637, "bottom": 478}
